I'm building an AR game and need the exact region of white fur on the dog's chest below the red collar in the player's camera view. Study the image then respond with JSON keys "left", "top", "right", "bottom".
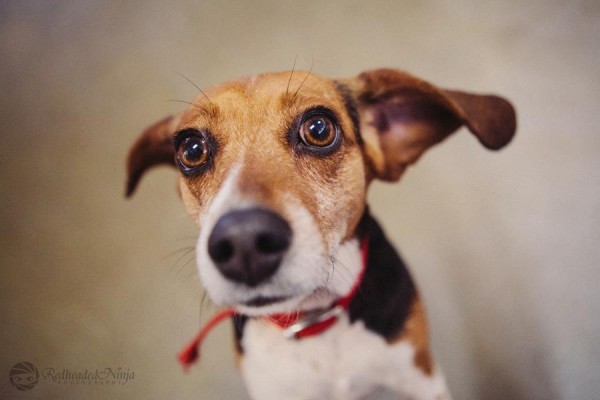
{"left": 241, "top": 315, "right": 450, "bottom": 400}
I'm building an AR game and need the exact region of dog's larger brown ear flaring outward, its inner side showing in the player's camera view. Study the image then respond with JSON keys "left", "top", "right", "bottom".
{"left": 345, "top": 69, "right": 516, "bottom": 181}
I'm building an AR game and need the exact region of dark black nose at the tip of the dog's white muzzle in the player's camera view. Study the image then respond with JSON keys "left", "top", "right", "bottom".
{"left": 208, "top": 208, "right": 292, "bottom": 286}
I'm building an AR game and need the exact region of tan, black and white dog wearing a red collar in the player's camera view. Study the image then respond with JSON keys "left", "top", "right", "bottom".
{"left": 126, "top": 69, "right": 516, "bottom": 400}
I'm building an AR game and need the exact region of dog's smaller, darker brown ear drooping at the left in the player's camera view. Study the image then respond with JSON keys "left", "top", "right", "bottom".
{"left": 125, "top": 115, "right": 181, "bottom": 197}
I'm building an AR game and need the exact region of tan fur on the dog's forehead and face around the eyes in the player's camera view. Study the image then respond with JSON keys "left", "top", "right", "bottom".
{"left": 173, "top": 72, "right": 366, "bottom": 247}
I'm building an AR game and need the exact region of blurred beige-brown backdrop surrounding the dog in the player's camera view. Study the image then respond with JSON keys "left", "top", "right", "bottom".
{"left": 0, "top": 0, "right": 600, "bottom": 400}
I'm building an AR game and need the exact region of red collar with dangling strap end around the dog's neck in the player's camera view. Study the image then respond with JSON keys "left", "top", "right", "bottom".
{"left": 177, "top": 238, "right": 369, "bottom": 371}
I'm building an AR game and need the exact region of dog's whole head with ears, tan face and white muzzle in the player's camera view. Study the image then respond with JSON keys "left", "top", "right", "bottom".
{"left": 127, "top": 70, "right": 516, "bottom": 315}
